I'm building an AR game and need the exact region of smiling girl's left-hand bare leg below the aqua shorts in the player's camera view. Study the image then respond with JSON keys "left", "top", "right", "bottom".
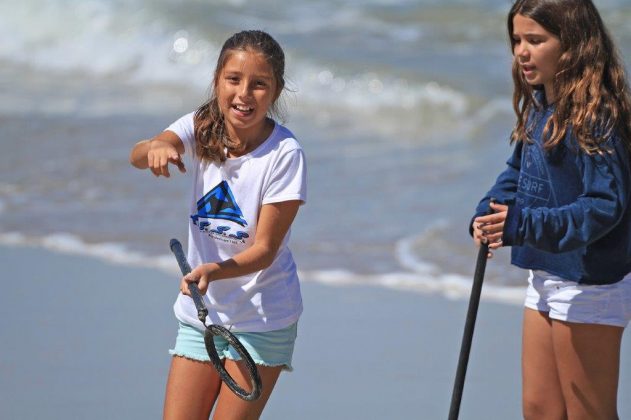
{"left": 163, "top": 356, "right": 221, "bottom": 420}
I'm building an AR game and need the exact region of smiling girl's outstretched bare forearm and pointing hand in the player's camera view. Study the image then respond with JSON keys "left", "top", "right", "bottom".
{"left": 129, "top": 130, "right": 186, "bottom": 178}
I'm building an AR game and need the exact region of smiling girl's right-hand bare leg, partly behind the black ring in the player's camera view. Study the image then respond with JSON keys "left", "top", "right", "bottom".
{"left": 213, "top": 359, "right": 283, "bottom": 420}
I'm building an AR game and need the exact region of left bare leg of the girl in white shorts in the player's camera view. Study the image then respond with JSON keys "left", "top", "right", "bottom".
{"left": 522, "top": 308, "right": 567, "bottom": 420}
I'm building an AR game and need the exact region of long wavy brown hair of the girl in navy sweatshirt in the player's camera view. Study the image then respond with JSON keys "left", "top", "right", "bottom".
{"left": 507, "top": 0, "right": 631, "bottom": 154}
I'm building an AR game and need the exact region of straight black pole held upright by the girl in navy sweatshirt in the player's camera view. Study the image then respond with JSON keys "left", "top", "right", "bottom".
{"left": 449, "top": 238, "right": 489, "bottom": 420}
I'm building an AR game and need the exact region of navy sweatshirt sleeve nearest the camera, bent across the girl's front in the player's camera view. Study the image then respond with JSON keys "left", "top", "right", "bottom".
{"left": 502, "top": 141, "right": 629, "bottom": 253}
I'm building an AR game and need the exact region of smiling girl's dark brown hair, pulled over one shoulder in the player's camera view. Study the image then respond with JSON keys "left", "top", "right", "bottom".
{"left": 194, "top": 30, "right": 285, "bottom": 162}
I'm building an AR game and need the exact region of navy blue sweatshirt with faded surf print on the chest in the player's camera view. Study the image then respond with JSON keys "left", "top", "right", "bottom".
{"left": 474, "top": 98, "right": 631, "bottom": 284}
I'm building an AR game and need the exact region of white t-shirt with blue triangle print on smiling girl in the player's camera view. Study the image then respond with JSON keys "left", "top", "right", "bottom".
{"left": 167, "top": 113, "right": 306, "bottom": 332}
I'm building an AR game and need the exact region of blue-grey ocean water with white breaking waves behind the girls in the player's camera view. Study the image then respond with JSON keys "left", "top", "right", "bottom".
{"left": 0, "top": 0, "right": 631, "bottom": 302}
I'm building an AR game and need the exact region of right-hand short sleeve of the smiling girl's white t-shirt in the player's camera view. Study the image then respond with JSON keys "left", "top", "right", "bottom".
{"left": 263, "top": 148, "right": 307, "bottom": 204}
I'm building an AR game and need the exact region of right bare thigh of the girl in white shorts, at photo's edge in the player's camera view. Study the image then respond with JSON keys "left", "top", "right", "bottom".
{"left": 552, "top": 320, "right": 623, "bottom": 420}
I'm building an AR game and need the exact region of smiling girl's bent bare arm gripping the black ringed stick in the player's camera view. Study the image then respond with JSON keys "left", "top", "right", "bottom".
{"left": 180, "top": 200, "right": 301, "bottom": 296}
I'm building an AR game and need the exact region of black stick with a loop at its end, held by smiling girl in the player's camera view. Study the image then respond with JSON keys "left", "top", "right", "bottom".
{"left": 169, "top": 239, "right": 263, "bottom": 401}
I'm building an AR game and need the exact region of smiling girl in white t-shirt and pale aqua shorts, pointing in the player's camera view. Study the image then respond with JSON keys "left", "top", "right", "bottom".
{"left": 130, "top": 31, "right": 306, "bottom": 419}
